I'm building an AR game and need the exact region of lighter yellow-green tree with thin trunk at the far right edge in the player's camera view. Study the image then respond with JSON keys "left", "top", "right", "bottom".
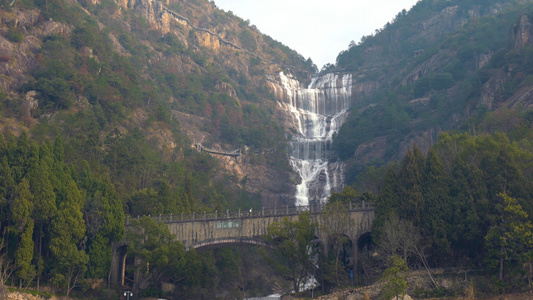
{"left": 485, "top": 193, "right": 533, "bottom": 281}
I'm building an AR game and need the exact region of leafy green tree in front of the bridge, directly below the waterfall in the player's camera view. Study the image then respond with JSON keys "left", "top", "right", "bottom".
{"left": 265, "top": 212, "right": 315, "bottom": 292}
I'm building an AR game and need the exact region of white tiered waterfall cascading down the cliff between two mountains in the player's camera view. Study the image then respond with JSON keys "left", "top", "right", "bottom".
{"left": 272, "top": 72, "right": 352, "bottom": 205}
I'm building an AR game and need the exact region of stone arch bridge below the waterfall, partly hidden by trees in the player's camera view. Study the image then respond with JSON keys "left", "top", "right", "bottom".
{"left": 110, "top": 201, "right": 374, "bottom": 285}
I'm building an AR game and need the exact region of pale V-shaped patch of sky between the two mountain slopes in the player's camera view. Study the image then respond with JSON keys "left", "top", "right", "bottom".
{"left": 214, "top": 0, "right": 418, "bottom": 69}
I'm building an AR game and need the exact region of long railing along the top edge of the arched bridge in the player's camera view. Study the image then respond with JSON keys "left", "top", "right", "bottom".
{"left": 126, "top": 201, "right": 374, "bottom": 225}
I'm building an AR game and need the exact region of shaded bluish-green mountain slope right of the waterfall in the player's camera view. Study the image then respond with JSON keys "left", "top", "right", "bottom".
{"left": 328, "top": 0, "right": 533, "bottom": 183}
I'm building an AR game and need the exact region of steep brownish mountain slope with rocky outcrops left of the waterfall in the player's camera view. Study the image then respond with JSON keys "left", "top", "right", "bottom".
{"left": 0, "top": 0, "right": 316, "bottom": 209}
